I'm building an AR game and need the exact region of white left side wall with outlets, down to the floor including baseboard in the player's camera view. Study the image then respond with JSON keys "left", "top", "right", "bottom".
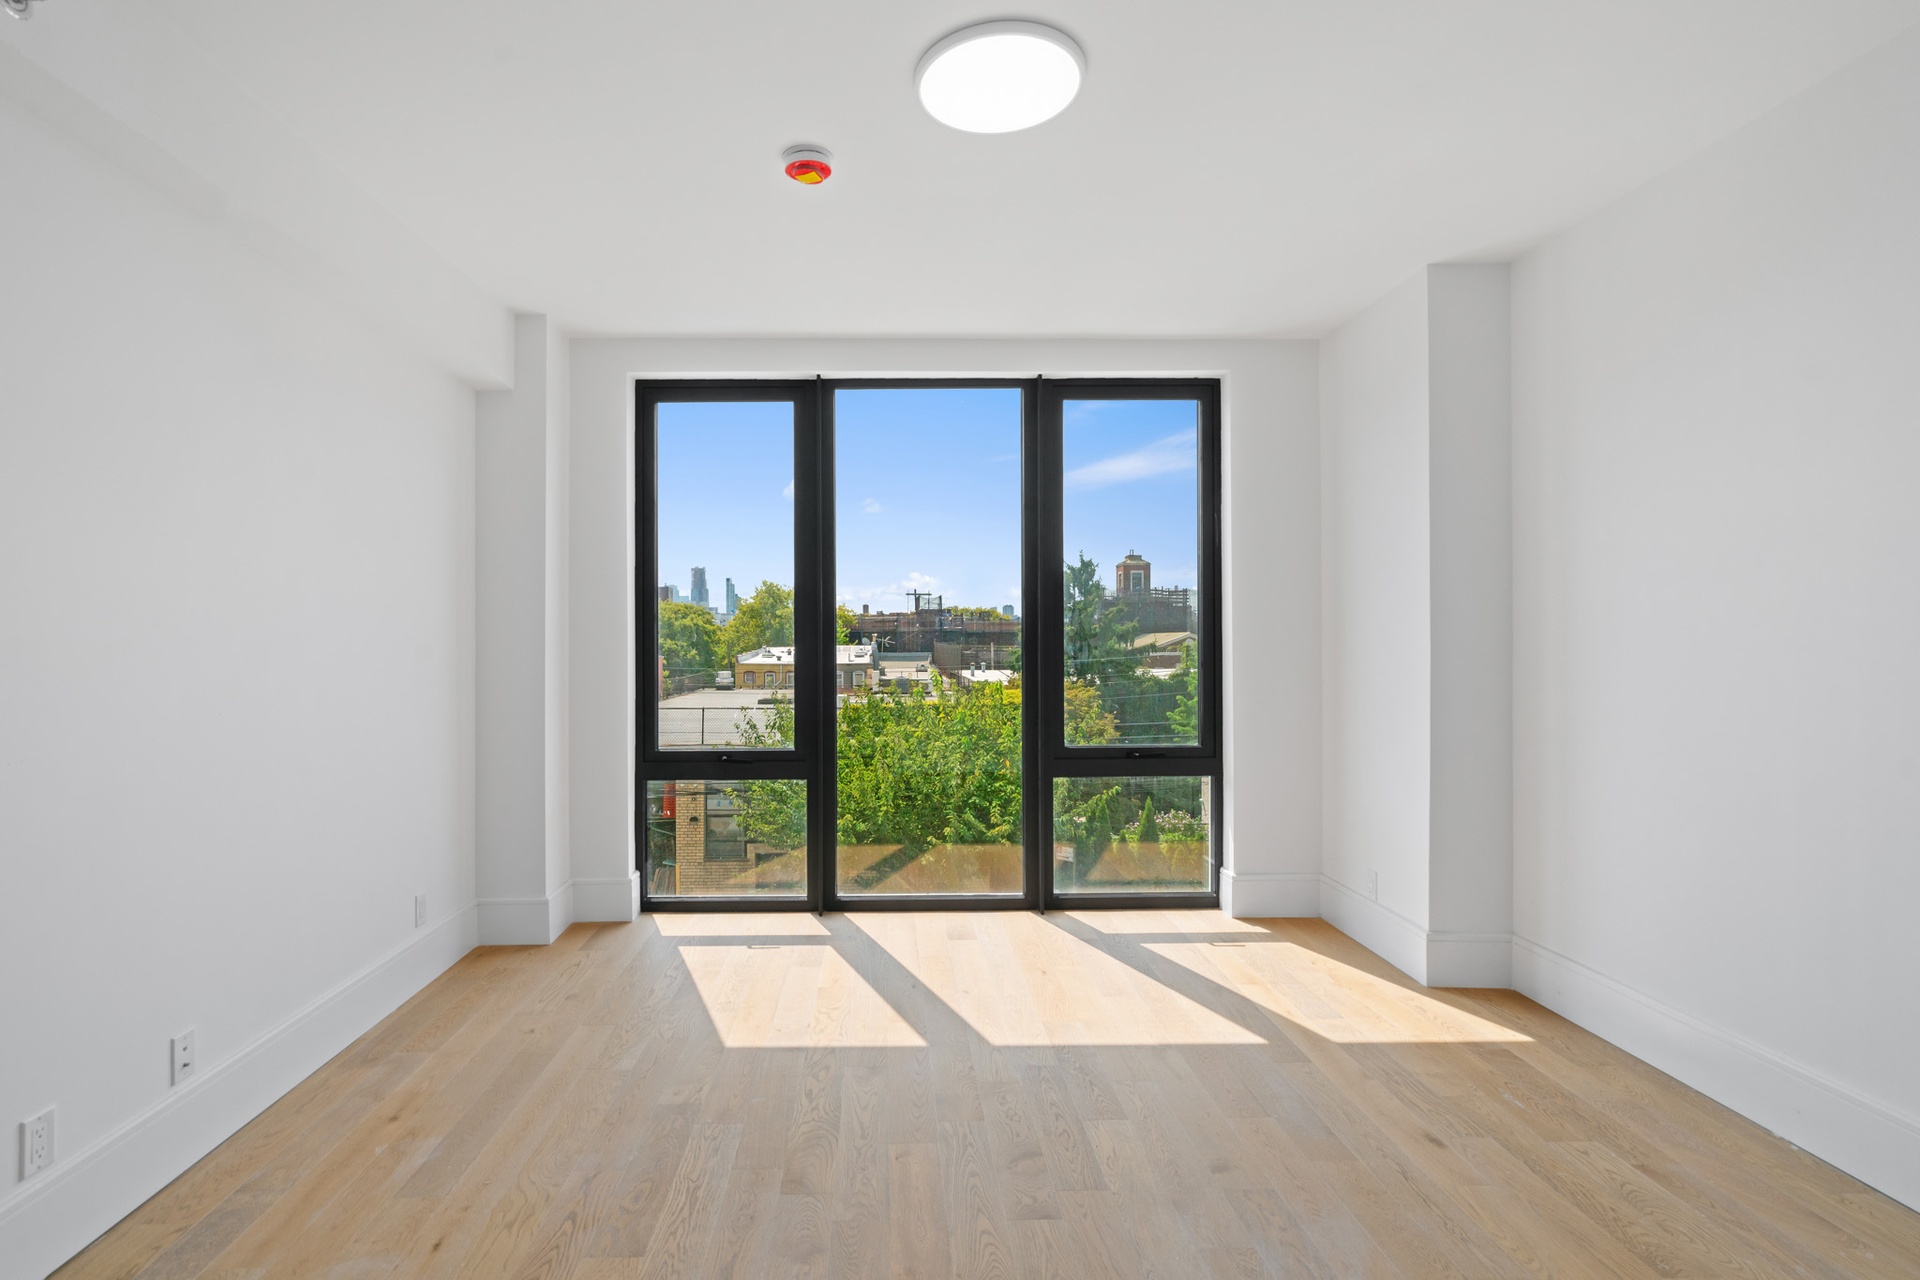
{"left": 0, "top": 98, "right": 474, "bottom": 1278}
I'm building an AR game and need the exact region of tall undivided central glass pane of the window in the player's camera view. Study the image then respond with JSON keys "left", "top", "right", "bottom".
{"left": 833, "top": 388, "right": 1025, "bottom": 894}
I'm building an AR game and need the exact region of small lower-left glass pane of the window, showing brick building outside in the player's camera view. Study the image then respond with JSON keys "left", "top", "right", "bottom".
{"left": 645, "top": 779, "right": 806, "bottom": 898}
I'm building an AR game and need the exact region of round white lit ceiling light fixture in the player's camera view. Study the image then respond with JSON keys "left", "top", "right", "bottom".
{"left": 914, "top": 21, "right": 1087, "bottom": 132}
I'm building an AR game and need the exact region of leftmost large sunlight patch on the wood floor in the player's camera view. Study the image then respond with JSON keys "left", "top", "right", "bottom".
{"left": 678, "top": 940, "right": 925, "bottom": 1050}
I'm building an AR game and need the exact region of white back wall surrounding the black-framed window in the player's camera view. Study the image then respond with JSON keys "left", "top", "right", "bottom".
{"left": 570, "top": 338, "right": 1319, "bottom": 915}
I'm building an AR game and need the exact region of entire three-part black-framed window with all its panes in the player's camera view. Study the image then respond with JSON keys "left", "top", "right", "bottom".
{"left": 636, "top": 380, "right": 1221, "bottom": 910}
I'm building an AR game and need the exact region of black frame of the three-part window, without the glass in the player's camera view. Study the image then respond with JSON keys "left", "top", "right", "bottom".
{"left": 634, "top": 376, "right": 1225, "bottom": 912}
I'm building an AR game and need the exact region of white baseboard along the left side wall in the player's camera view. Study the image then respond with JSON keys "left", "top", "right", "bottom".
{"left": 0, "top": 906, "right": 478, "bottom": 1280}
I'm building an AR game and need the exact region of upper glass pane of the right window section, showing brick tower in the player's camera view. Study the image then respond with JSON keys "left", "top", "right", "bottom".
{"left": 1062, "top": 399, "right": 1202, "bottom": 747}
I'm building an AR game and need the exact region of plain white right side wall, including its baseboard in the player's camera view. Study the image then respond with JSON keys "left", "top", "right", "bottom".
{"left": 1513, "top": 35, "right": 1920, "bottom": 1205}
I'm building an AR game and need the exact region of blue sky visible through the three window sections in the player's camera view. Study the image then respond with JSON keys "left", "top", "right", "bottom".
{"left": 659, "top": 388, "right": 1198, "bottom": 610}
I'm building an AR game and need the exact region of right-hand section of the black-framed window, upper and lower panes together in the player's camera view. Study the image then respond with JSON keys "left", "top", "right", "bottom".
{"left": 1039, "top": 382, "right": 1221, "bottom": 902}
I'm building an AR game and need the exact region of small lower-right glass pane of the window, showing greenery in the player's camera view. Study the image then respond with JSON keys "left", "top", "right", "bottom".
{"left": 1054, "top": 777, "right": 1213, "bottom": 894}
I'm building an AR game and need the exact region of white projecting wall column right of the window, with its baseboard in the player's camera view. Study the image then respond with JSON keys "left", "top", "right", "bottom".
{"left": 1321, "top": 265, "right": 1513, "bottom": 986}
